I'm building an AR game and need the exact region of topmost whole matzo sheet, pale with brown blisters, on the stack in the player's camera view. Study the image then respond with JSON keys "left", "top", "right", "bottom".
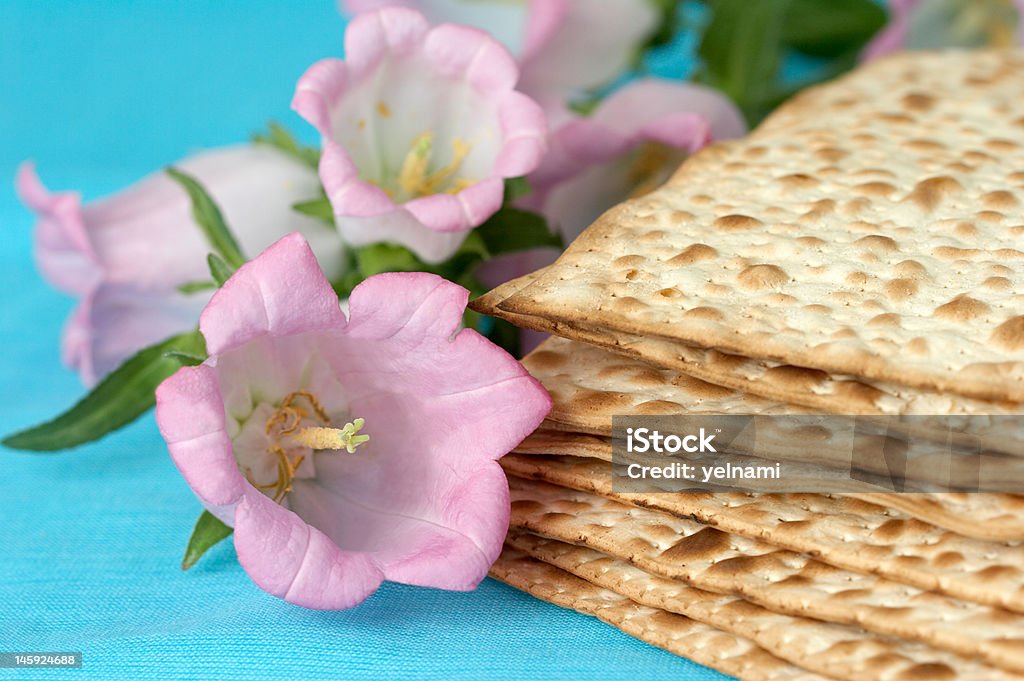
{"left": 483, "top": 51, "right": 1024, "bottom": 401}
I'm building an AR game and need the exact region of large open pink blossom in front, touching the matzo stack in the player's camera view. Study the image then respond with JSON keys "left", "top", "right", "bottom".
{"left": 157, "top": 235, "right": 551, "bottom": 609}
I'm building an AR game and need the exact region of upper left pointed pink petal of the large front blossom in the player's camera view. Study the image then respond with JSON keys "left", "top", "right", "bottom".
{"left": 200, "top": 232, "right": 345, "bottom": 355}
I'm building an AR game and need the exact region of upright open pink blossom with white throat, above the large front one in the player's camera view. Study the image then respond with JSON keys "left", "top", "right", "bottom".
{"left": 292, "top": 7, "right": 547, "bottom": 262}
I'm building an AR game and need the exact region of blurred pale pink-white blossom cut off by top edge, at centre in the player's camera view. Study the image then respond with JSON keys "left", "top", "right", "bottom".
{"left": 341, "top": 0, "right": 657, "bottom": 114}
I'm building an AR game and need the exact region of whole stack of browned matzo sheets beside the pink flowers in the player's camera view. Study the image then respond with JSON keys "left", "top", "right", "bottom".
{"left": 475, "top": 52, "right": 1024, "bottom": 681}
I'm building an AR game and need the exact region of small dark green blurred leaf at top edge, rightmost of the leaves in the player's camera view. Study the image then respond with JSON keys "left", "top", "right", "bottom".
{"left": 782, "top": 0, "right": 887, "bottom": 57}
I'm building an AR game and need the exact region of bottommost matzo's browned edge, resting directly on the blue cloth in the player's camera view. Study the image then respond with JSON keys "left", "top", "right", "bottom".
{"left": 490, "top": 547, "right": 825, "bottom": 681}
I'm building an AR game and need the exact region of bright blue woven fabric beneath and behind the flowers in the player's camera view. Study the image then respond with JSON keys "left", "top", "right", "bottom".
{"left": 0, "top": 0, "right": 724, "bottom": 680}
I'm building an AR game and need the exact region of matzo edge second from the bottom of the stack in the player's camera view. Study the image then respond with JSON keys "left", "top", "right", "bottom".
{"left": 506, "top": 533, "right": 1020, "bottom": 681}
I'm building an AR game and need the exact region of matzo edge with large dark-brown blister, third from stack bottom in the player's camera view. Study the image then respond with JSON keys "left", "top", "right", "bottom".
{"left": 510, "top": 477, "right": 1024, "bottom": 673}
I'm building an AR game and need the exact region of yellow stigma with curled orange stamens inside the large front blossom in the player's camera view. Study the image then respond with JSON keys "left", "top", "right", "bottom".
{"left": 246, "top": 390, "right": 370, "bottom": 503}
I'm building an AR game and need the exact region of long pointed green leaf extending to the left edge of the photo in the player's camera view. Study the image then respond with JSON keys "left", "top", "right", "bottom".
{"left": 3, "top": 331, "right": 206, "bottom": 452}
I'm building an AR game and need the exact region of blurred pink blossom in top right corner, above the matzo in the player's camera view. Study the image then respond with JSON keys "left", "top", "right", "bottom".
{"left": 861, "top": 0, "right": 1024, "bottom": 60}
